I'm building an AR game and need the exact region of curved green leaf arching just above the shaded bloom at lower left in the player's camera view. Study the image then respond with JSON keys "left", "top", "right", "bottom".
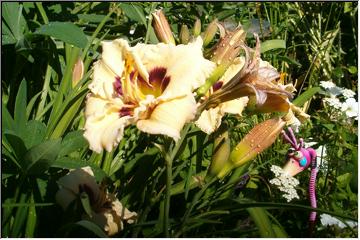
{"left": 51, "top": 157, "right": 107, "bottom": 182}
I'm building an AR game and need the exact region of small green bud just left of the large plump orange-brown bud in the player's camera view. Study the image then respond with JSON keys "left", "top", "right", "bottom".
{"left": 208, "top": 131, "right": 230, "bottom": 176}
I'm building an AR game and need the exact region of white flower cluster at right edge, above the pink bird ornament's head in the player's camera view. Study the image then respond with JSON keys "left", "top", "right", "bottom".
{"left": 320, "top": 81, "right": 359, "bottom": 119}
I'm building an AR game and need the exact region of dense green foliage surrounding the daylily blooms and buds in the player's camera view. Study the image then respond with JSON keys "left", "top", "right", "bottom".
{"left": 1, "top": 2, "right": 358, "bottom": 237}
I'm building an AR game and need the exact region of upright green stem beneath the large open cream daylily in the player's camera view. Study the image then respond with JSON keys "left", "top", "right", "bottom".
{"left": 164, "top": 124, "right": 190, "bottom": 237}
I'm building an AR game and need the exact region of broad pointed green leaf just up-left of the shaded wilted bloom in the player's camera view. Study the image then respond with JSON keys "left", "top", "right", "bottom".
{"left": 24, "top": 139, "right": 61, "bottom": 174}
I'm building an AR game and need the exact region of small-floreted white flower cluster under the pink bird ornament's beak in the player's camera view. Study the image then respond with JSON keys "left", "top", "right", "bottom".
{"left": 270, "top": 165, "right": 299, "bottom": 202}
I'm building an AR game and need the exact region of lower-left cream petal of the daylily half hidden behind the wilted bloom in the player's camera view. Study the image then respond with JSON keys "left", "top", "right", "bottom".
{"left": 195, "top": 107, "right": 224, "bottom": 134}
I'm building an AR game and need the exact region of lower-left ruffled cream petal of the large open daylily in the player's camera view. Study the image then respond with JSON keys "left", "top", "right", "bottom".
{"left": 84, "top": 96, "right": 130, "bottom": 153}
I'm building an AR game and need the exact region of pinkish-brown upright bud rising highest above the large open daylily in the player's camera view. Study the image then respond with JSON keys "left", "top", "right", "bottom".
{"left": 152, "top": 10, "right": 175, "bottom": 44}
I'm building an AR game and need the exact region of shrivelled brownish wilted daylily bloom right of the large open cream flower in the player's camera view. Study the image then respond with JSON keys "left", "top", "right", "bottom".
{"left": 200, "top": 34, "right": 291, "bottom": 115}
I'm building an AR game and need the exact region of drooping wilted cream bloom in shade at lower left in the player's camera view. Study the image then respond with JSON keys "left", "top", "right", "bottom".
{"left": 56, "top": 167, "right": 137, "bottom": 236}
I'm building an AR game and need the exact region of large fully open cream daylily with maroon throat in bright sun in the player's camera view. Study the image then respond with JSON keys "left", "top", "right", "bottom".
{"left": 84, "top": 37, "right": 215, "bottom": 152}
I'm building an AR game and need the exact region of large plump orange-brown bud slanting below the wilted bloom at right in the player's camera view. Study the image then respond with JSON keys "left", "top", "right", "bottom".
{"left": 218, "top": 118, "right": 285, "bottom": 178}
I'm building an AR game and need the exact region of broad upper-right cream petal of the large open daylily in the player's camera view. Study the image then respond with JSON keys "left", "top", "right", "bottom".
{"left": 133, "top": 37, "right": 215, "bottom": 96}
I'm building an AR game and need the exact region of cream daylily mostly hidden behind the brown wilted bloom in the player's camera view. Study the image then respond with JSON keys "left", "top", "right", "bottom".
{"left": 195, "top": 57, "right": 249, "bottom": 134}
